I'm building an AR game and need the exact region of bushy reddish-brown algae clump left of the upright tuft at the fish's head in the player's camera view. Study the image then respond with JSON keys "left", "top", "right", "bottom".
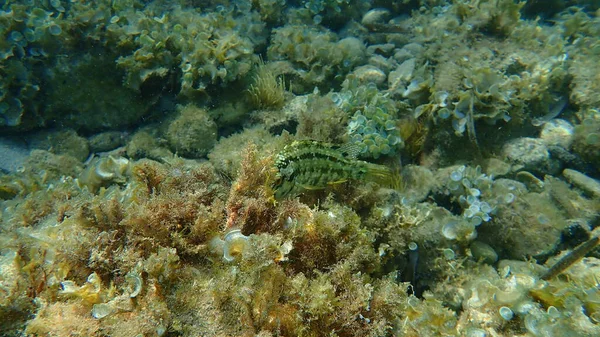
{"left": 122, "top": 158, "right": 224, "bottom": 254}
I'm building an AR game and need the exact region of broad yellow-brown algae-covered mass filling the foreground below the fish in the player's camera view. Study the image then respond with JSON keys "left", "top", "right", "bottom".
{"left": 0, "top": 135, "right": 597, "bottom": 336}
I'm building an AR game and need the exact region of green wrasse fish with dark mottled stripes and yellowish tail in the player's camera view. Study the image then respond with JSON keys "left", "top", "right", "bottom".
{"left": 274, "top": 140, "right": 394, "bottom": 199}
